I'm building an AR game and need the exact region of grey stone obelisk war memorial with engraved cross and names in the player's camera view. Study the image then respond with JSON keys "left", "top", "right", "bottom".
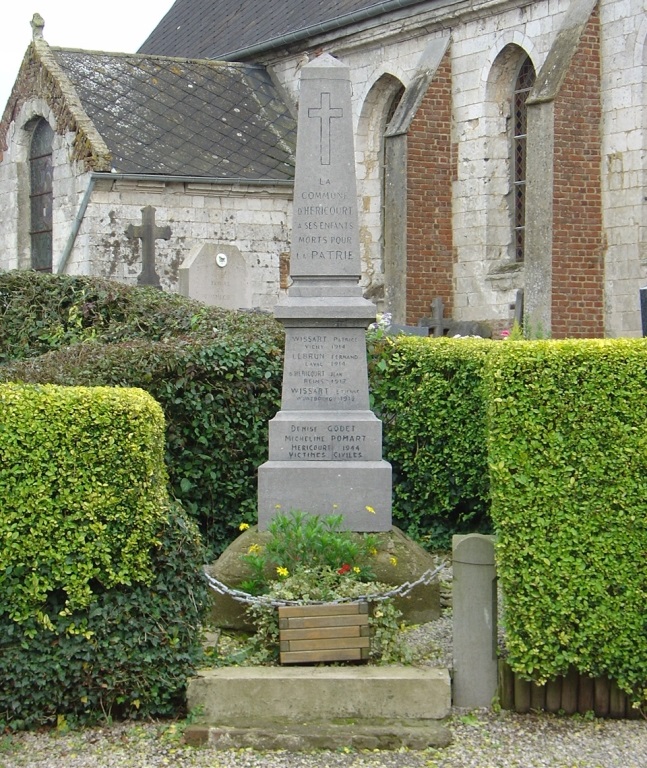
{"left": 258, "top": 54, "right": 391, "bottom": 531}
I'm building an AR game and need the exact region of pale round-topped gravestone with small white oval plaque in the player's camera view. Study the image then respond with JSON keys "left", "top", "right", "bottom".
{"left": 179, "top": 243, "right": 252, "bottom": 309}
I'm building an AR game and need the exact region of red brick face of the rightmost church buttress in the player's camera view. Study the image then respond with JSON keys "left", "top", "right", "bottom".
{"left": 552, "top": 5, "right": 605, "bottom": 338}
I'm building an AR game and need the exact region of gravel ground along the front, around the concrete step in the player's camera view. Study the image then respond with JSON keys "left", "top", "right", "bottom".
{"left": 0, "top": 710, "right": 647, "bottom": 768}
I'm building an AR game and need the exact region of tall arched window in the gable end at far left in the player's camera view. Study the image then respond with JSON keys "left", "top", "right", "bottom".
{"left": 29, "top": 119, "right": 54, "bottom": 272}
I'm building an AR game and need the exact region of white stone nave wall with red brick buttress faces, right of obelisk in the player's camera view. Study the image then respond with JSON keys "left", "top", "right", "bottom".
{"left": 272, "top": 0, "right": 647, "bottom": 337}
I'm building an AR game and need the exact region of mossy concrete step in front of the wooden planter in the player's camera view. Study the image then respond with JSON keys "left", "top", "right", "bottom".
{"left": 185, "top": 666, "right": 451, "bottom": 750}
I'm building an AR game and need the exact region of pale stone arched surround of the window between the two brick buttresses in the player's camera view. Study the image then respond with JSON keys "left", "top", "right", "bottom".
{"left": 484, "top": 42, "right": 536, "bottom": 302}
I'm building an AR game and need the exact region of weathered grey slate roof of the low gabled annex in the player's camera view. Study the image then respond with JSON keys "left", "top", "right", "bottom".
{"left": 52, "top": 48, "right": 296, "bottom": 180}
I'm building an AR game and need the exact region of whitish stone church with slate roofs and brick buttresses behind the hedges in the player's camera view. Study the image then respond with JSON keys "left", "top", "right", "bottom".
{"left": 0, "top": 0, "right": 647, "bottom": 338}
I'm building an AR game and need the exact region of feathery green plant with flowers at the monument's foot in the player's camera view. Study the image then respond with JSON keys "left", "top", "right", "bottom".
{"left": 241, "top": 511, "right": 377, "bottom": 594}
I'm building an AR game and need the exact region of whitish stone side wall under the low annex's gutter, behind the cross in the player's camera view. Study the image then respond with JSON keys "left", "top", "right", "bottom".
{"left": 66, "top": 178, "right": 291, "bottom": 310}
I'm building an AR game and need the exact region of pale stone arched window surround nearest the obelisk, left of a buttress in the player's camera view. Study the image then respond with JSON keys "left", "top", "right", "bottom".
{"left": 355, "top": 73, "right": 404, "bottom": 308}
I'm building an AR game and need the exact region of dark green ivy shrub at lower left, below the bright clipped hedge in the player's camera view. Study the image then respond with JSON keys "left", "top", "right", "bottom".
{"left": 0, "top": 507, "right": 207, "bottom": 729}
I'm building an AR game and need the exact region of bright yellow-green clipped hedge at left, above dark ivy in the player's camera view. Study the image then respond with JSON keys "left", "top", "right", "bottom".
{"left": 0, "top": 384, "right": 168, "bottom": 625}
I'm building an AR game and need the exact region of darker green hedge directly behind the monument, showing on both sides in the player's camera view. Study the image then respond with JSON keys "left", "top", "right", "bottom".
{"left": 0, "top": 272, "right": 493, "bottom": 554}
